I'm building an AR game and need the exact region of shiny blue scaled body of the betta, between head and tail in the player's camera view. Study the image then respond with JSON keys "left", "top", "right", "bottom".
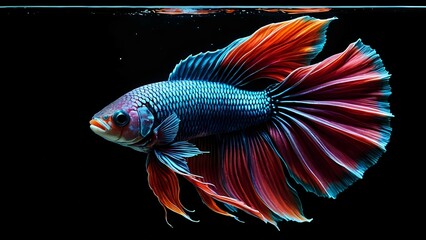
{"left": 128, "top": 80, "right": 271, "bottom": 140}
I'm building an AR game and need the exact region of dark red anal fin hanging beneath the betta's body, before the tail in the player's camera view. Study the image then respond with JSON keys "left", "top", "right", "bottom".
{"left": 188, "top": 130, "right": 310, "bottom": 227}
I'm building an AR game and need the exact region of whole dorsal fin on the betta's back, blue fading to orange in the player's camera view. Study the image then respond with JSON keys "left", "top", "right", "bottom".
{"left": 169, "top": 17, "right": 334, "bottom": 87}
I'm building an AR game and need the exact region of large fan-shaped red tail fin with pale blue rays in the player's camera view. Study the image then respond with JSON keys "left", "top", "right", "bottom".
{"left": 268, "top": 40, "right": 392, "bottom": 198}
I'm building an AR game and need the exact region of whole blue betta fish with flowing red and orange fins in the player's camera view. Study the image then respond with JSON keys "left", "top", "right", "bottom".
{"left": 90, "top": 16, "right": 393, "bottom": 228}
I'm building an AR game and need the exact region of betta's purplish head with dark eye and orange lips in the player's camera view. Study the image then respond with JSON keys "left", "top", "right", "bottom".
{"left": 90, "top": 95, "right": 142, "bottom": 146}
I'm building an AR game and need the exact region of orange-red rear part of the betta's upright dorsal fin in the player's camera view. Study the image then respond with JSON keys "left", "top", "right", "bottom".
{"left": 221, "top": 17, "right": 334, "bottom": 83}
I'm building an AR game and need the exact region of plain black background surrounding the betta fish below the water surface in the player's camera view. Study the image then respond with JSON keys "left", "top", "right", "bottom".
{"left": 0, "top": 5, "right": 426, "bottom": 239}
